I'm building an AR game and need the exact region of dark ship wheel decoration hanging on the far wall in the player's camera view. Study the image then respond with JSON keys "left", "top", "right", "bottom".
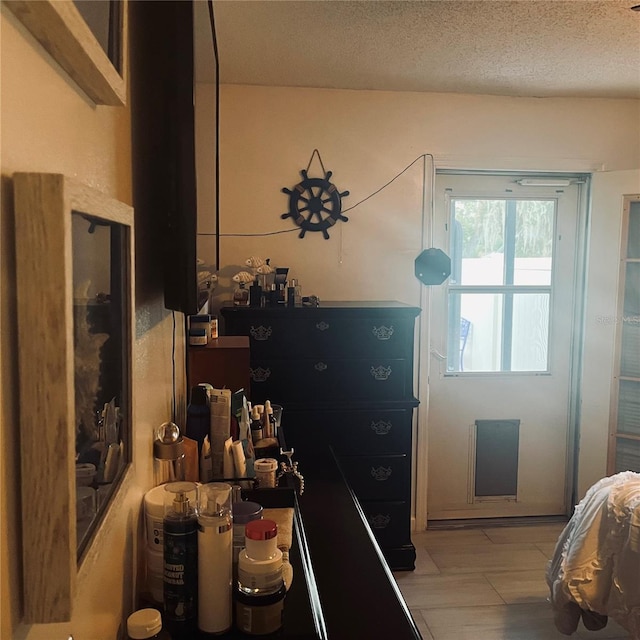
{"left": 281, "top": 167, "right": 349, "bottom": 240}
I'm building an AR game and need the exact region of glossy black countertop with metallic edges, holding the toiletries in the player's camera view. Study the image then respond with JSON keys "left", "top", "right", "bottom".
{"left": 160, "top": 432, "right": 422, "bottom": 640}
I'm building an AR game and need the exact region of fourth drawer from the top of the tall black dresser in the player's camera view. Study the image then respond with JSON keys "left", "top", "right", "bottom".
{"left": 340, "top": 455, "right": 411, "bottom": 502}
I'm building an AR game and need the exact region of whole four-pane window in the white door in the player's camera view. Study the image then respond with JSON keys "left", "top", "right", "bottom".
{"left": 447, "top": 197, "right": 557, "bottom": 373}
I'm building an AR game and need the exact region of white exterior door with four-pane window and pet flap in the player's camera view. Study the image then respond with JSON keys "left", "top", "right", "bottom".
{"left": 423, "top": 173, "right": 585, "bottom": 520}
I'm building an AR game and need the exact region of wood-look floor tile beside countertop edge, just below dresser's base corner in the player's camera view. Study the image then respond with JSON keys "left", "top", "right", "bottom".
{"left": 398, "top": 574, "right": 504, "bottom": 610}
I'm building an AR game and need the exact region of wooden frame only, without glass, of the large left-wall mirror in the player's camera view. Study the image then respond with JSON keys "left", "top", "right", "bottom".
{"left": 13, "top": 173, "right": 135, "bottom": 623}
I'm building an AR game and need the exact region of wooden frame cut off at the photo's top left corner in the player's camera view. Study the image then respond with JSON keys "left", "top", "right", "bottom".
{"left": 3, "top": 0, "right": 127, "bottom": 107}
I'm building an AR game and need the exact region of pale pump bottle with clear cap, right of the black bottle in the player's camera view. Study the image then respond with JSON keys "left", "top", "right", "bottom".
{"left": 196, "top": 482, "right": 233, "bottom": 634}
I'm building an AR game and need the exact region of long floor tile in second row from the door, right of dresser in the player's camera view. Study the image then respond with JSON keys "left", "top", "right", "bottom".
{"left": 429, "top": 544, "right": 547, "bottom": 573}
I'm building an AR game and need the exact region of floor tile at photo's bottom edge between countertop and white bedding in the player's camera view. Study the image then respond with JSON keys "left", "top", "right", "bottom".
{"left": 421, "top": 603, "right": 567, "bottom": 640}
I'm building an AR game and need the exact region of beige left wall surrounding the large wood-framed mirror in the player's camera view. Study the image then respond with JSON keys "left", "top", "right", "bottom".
{"left": 0, "top": 5, "right": 183, "bottom": 640}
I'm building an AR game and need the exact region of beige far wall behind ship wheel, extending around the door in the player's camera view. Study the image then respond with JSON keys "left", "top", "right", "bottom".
{"left": 214, "top": 86, "right": 640, "bottom": 524}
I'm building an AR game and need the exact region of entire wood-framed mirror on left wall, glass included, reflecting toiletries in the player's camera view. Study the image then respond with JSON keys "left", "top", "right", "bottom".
{"left": 13, "top": 173, "right": 135, "bottom": 622}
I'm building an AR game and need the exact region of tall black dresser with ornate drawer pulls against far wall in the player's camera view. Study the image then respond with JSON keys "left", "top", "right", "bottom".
{"left": 221, "top": 302, "right": 420, "bottom": 570}
